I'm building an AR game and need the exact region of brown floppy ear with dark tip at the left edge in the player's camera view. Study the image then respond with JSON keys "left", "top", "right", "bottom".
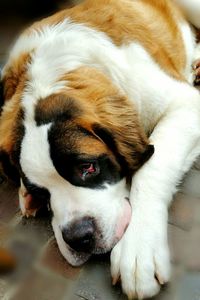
{"left": 0, "top": 59, "right": 27, "bottom": 184}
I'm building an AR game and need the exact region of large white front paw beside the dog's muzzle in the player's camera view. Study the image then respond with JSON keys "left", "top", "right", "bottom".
{"left": 111, "top": 226, "right": 170, "bottom": 299}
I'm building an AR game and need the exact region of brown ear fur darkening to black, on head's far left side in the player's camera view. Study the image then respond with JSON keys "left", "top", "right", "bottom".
{"left": 0, "top": 61, "right": 26, "bottom": 183}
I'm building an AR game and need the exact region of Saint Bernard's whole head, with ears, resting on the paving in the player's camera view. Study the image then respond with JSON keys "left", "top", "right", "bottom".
{"left": 0, "top": 68, "right": 153, "bottom": 265}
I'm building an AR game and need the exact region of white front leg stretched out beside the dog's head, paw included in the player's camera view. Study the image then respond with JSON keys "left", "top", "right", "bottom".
{"left": 111, "top": 81, "right": 200, "bottom": 299}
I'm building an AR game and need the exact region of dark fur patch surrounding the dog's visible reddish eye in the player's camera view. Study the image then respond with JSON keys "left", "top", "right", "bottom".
{"left": 48, "top": 122, "right": 122, "bottom": 188}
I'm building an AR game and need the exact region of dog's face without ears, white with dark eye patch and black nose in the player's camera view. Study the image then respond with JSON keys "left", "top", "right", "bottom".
{"left": 20, "top": 110, "right": 131, "bottom": 264}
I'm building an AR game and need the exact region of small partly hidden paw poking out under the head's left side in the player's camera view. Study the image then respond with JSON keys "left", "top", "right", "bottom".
{"left": 19, "top": 185, "right": 41, "bottom": 218}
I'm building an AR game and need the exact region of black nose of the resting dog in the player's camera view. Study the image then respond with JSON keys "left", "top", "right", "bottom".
{"left": 62, "top": 218, "right": 95, "bottom": 253}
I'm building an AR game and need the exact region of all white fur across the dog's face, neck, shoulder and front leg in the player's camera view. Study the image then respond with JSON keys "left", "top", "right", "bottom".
{"left": 4, "top": 0, "right": 200, "bottom": 298}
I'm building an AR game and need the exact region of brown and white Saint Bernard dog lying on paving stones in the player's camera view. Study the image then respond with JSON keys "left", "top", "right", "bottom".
{"left": 0, "top": 0, "right": 200, "bottom": 299}
